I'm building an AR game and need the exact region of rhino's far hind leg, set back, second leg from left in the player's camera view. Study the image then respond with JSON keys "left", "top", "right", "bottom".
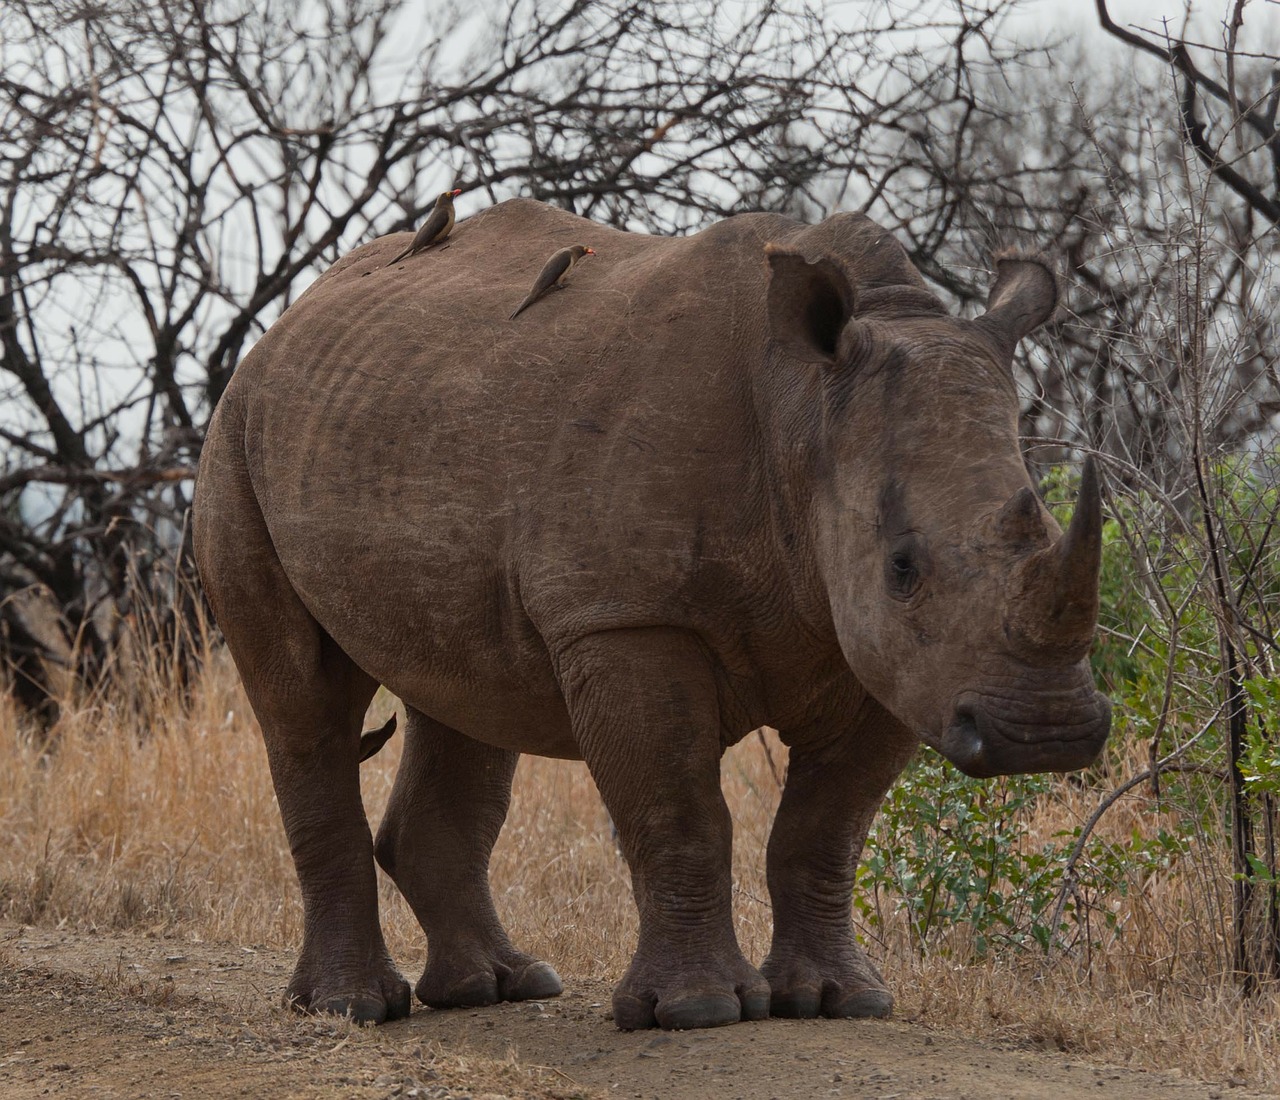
{"left": 375, "top": 708, "right": 562, "bottom": 1008}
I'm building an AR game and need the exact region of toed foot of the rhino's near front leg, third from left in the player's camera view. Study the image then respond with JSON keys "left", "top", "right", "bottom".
{"left": 613, "top": 959, "right": 769, "bottom": 1031}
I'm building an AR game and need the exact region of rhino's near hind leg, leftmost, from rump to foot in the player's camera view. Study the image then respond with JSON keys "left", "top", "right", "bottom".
{"left": 196, "top": 439, "right": 410, "bottom": 1023}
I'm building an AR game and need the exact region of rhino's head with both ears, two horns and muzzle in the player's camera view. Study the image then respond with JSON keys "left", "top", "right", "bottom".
{"left": 768, "top": 246, "right": 1111, "bottom": 776}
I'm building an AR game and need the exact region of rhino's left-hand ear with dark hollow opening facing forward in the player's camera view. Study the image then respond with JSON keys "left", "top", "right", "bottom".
{"left": 764, "top": 243, "right": 854, "bottom": 364}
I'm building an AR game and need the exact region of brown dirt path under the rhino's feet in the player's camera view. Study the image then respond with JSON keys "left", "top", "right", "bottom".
{"left": 0, "top": 925, "right": 1275, "bottom": 1100}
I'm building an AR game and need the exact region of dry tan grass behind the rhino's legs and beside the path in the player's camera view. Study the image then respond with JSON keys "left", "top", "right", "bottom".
{"left": 0, "top": 653, "right": 1280, "bottom": 1083}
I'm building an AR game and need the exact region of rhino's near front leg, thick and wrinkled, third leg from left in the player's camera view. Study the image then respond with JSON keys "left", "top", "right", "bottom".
{"left": 559, "top": 629, "right": 769, "bottom": 1031}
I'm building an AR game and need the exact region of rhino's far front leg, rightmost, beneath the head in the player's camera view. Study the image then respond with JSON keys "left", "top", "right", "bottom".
{"left": 760, "top": 699, "right": 918, "bottom": 1017}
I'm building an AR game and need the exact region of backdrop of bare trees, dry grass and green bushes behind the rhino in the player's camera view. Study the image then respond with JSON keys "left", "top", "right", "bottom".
{"left": 0, "top": 0, "right": 1280, "bottom": 1082}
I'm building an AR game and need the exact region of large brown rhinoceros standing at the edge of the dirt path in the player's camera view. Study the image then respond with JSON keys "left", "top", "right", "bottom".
{"left": 195, "top": 200, "right": 1110, "bottom": 1030}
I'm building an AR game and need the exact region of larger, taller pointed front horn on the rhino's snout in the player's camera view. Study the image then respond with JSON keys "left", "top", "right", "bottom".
{"left": 1009, "top": 456, "right": 1102, "bottom": 658}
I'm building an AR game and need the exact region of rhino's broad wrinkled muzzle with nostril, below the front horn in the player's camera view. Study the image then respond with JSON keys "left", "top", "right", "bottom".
{"left": 938, "top": 685, "right": 1111, "bottom": 779}
